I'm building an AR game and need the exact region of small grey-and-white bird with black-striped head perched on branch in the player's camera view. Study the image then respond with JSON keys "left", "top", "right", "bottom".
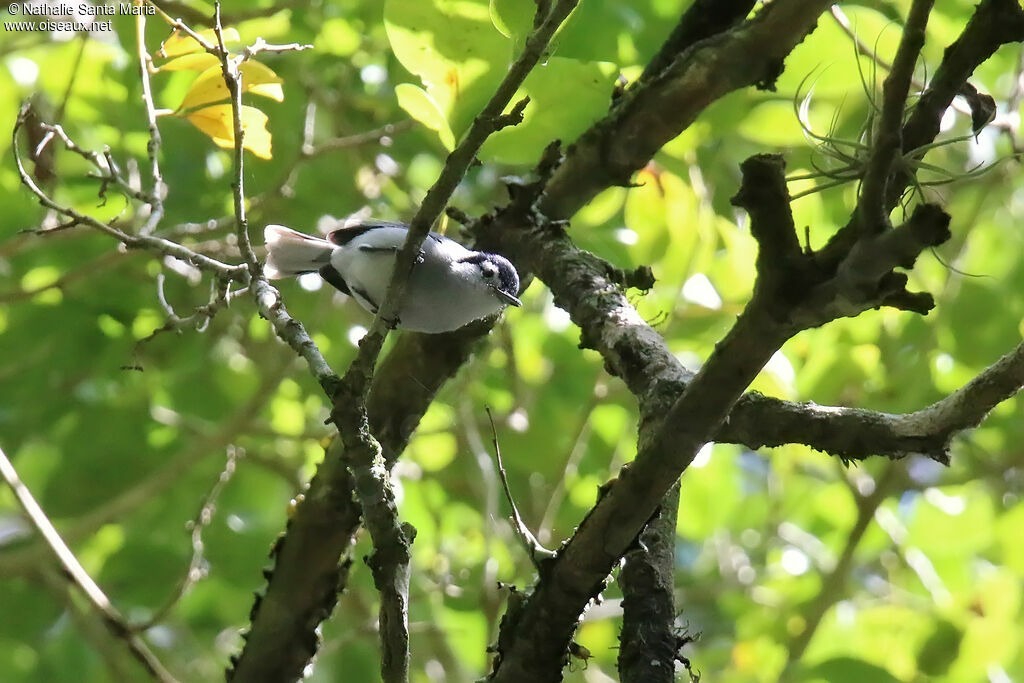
{"left": 263, "top": 221, "right": 522, "bottom": 333}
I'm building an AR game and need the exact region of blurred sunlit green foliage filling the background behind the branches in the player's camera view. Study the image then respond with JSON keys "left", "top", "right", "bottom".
{"left": 0, "top": 0, "right": 1024, "bottom": 683}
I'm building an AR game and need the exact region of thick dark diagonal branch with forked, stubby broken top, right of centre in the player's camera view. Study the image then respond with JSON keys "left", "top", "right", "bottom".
{"left": 483, "top": 107, "right": 987, "bottom": 681}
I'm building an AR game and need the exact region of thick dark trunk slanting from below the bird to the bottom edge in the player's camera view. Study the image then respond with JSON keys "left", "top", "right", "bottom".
{"left": 228, "top": 323, "right": 489, "bottom": 681}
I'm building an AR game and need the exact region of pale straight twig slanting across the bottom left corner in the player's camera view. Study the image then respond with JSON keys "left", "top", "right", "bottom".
{"left": 0, "top": 449, "right": 176, "bottom": 683}
